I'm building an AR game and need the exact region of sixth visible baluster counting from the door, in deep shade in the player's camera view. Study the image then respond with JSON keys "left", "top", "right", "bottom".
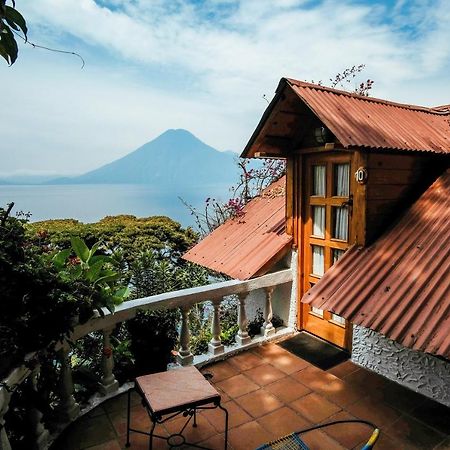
{"left": 58, "top": 342, "right": 80, "bottom": 422}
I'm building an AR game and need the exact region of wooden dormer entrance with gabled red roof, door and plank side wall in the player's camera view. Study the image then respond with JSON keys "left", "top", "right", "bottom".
{"left": 242, "top": 78, "right": 450, "bottom": 356}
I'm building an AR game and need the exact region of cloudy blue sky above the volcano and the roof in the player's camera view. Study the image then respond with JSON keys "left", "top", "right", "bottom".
{"left": 0, "top": 0, "right": 450, "bottom": 176}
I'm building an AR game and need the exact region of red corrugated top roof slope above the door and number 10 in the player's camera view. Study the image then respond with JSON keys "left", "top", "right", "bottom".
{"left": 287, "top": 79, "right": 450, "bottom": 153}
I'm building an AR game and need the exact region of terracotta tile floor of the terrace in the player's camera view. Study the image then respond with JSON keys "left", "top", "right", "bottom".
{"left": 52, "top": 344, "right": 450, "bottom": 450}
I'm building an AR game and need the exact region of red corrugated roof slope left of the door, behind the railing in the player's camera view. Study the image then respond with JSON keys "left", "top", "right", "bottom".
{"left": 183, "top": 177, "right": 292, "bottom": 280}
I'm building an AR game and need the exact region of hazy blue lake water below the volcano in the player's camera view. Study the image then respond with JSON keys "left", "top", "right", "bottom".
{"left": 0, "top": 184, "right": 229, "bottom": 227}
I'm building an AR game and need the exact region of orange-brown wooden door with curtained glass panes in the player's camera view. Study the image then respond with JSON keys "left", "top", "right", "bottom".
{"left": 301, "top": 155, "right": 353, "bottom": 348}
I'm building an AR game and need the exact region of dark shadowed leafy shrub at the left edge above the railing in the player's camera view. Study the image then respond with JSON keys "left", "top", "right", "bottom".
{"left": 0, "top": 208, "right": 80, "bottom": 375}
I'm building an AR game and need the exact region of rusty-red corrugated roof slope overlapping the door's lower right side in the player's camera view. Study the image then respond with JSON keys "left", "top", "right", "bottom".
{"left": 302, "top": 170, "right": 450, "bottom": 359}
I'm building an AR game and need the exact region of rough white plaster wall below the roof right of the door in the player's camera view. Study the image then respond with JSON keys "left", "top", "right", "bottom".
{"left": 352, "top": 325, "right": 450, "bottom": 406}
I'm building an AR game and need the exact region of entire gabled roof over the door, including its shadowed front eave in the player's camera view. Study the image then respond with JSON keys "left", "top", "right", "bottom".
{"left": 242, "top": 78, "right": 450, "bottom": 157}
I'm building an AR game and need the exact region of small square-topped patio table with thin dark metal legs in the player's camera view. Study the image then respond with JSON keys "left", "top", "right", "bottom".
{"left": 126, "top": 366, "right": 228, "bottom": 450}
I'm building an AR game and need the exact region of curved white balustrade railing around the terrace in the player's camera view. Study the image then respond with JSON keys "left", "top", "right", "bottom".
{"left": 0, "top": 269, "right": 293, "bottom": 450}
